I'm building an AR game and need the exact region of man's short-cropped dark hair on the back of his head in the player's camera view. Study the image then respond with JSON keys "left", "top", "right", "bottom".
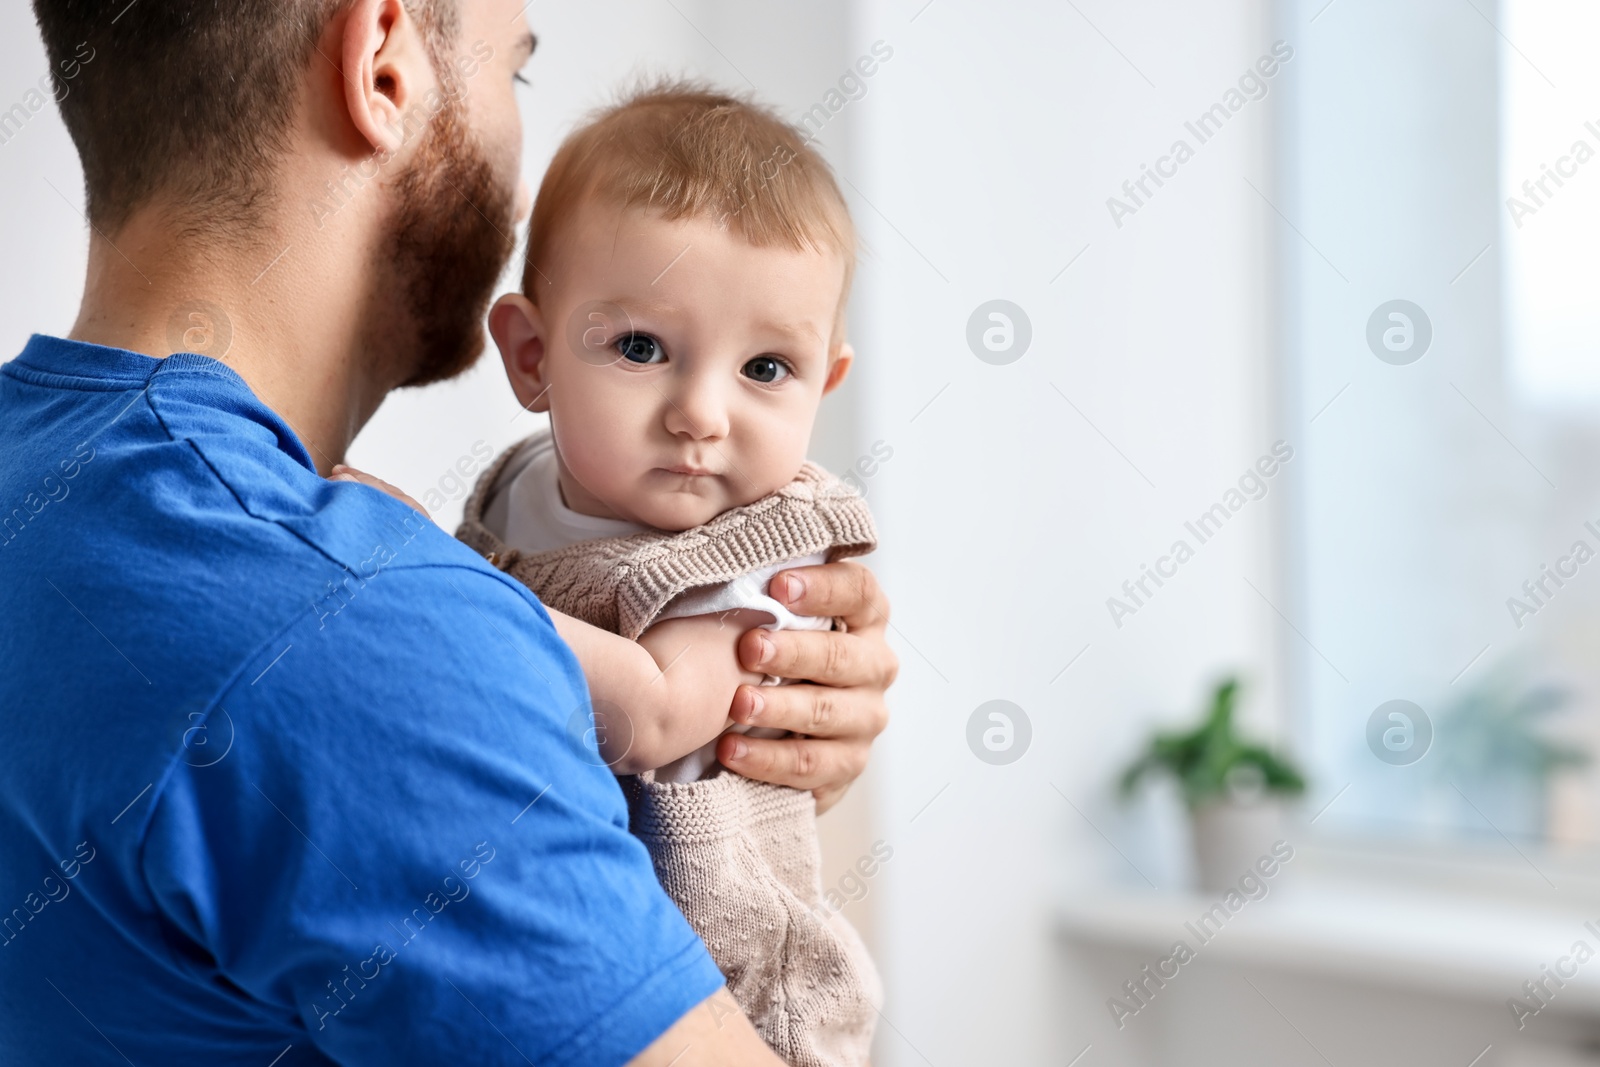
{"left": 34, "top": 0, "right": 456, "bottom": 232}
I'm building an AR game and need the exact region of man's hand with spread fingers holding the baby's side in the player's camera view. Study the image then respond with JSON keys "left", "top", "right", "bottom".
{"left": 717, "top": 563, "right": 899, "bottom": 813}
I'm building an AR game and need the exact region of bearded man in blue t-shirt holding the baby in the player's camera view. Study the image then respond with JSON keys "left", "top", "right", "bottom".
{"left": 0, "top": 0, "right": 894, "bottom": 1067}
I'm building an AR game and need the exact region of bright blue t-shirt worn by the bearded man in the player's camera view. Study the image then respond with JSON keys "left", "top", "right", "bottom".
{"left": 0, "top": 338, "right": 722, "bottom": 1067}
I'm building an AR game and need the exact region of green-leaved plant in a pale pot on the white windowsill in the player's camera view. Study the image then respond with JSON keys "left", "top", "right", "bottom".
{"left": 1118, "top": 677, "right": 1306, "bottom": 891}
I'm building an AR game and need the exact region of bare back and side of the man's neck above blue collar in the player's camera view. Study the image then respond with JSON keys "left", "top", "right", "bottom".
{"left": 69, "top": 213, "right": 397, "bottom": 474}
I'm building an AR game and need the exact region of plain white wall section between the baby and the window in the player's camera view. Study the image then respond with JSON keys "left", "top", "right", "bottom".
{"left": 850, "top": 0, "right": 1296, "bottom": 1067}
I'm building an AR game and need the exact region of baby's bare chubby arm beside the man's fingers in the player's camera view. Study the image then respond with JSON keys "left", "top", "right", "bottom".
{"left": 550, "top": 609, "right": 768, "bottom": 774}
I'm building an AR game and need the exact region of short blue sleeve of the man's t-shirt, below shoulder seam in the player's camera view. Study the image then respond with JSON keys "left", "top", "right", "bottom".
{"left": 141, "top": 566, "right": 722, "bottom": 1067}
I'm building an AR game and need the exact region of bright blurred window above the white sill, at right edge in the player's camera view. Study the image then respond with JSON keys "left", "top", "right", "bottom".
{"left": 1278, "top": 0, "right": 1600, "bottom": 848}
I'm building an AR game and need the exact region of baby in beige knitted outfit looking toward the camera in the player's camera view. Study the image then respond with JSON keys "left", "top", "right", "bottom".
{"left": 458, "top": 85, "right": 882, "bottom": 1067}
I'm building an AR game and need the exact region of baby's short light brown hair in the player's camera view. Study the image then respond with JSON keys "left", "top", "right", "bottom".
{"left": 522, "top": 80, "right": 856, "bottom": 341}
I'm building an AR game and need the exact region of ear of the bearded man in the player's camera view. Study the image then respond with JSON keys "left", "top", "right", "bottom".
{"left": 339, "top": 0, "right": 438, "bottom": 152}
